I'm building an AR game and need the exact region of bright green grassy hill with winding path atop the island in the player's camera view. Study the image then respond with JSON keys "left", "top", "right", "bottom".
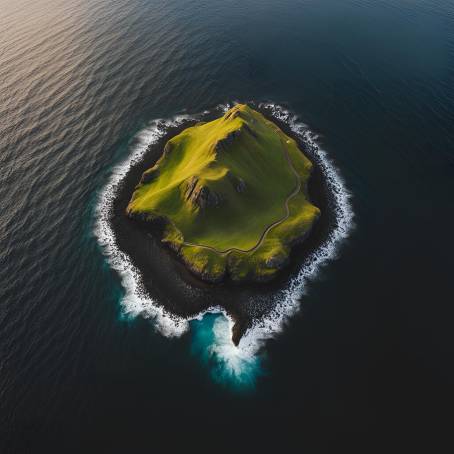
{"left": 127, "top": 104, "right": 320, "bottom": 281}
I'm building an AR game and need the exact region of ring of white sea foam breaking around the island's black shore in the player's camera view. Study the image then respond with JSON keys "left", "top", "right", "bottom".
{"left": 95, "top": 104, "right": 353, "bottom": 366}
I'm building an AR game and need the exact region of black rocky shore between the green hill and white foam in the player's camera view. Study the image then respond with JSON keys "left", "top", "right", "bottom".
{"left": 110, "top": 106, "right": 335, "bottom": 343}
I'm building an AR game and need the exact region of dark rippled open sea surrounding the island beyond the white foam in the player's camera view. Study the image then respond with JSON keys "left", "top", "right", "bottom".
{"left": 0, "top": 0, "right": 454, "bottom": 453}
